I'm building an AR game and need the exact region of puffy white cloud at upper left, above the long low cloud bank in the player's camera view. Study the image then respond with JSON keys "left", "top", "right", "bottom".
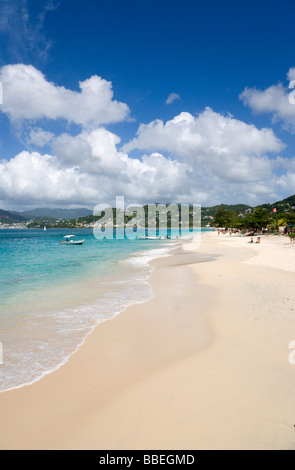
{"left": 0, "top": 64, "right": 129, "bottom": 126}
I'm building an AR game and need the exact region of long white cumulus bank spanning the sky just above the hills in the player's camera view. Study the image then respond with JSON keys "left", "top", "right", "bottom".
{"left": 0, "top": 110, "right": 295, "bottom": 206}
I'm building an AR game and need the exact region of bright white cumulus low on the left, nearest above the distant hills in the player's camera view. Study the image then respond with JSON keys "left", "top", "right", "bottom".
{"left": 0, "top": 129, "right": 191, "bottom": 206}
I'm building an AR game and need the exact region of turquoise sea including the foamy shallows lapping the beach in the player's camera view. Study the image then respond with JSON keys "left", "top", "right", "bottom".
{"left": 0, "top": 229, "right": 191, "bottom": 392}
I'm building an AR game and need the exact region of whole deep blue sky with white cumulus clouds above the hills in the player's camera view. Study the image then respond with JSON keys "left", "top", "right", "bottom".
{"left": 0, "top": 0, "right": 295, "bottom": 210}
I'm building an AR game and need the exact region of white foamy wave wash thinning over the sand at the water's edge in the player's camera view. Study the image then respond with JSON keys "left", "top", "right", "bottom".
{"left": 0, "top": 244, "right": 179, "bottom": 393}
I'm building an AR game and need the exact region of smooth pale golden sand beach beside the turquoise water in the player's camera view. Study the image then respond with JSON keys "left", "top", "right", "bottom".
{"left": 0, "top": 232, "right": 295, "bottom": 450}
